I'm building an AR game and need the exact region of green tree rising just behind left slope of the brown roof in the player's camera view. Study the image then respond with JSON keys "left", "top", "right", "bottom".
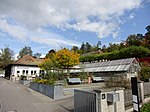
{"left": 18, "top": 46, "right": 32, "bottom": 58}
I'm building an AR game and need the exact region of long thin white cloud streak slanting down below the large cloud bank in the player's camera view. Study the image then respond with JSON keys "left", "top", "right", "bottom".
{"left": 0, "top": 19, "right": 80, "bottom": 48}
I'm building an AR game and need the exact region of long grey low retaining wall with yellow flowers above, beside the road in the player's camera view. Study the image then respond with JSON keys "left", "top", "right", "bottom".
{"left": 29, "top": 82, "right": 63, "bottom": 99}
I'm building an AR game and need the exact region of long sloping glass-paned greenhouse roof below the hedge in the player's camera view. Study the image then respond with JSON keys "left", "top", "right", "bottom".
{"left": 70, "top": 58, "right": 137, "bottom": 73}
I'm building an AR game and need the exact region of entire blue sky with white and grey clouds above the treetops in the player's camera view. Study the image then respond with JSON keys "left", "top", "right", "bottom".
{"left": 0, "top": 0, "right": 150, "bottom": 55}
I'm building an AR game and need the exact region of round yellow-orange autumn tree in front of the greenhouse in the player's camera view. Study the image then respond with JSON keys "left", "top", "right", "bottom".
{"left": 55, "top": 48, "right": 79, "bottom": 74}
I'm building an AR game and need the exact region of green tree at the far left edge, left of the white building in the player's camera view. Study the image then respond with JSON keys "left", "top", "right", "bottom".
{"left": 0, "top": 47, "right": 14, "bottom": 68}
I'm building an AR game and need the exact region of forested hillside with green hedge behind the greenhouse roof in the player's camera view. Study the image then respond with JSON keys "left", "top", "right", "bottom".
{"left": 72, "top": 25, "right": 150, "bottom": 62}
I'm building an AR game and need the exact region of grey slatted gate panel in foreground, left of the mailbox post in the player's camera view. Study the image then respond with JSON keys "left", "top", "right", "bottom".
{"left": 74, "top": 90, "right": 97, "bottom": 112}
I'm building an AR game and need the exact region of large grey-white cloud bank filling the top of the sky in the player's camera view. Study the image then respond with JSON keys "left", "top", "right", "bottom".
{"left": 0, "top": 0, "right": 142, "bottom": 38}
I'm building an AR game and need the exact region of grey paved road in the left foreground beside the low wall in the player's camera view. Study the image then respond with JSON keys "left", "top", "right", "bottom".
{"left": 0, "top": 78, "right": 73, "bottom": 112}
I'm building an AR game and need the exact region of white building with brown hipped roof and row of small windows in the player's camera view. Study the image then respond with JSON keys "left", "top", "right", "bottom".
{"left": 5, "top": 55, "right": 43, "bottom": 80}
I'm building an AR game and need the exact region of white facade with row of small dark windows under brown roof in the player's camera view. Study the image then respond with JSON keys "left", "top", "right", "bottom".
{"left": 11, "top": 65, "right": 40, "bottom": 77}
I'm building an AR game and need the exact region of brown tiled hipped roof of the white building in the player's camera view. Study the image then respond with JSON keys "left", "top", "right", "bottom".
{"left": 13, "top": 54, "right": 44, "bottom": 65}
